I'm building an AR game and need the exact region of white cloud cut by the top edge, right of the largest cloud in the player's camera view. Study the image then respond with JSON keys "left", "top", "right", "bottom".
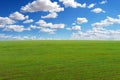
{"left": 59, "top": 0, "right": 86, "bottom": 8}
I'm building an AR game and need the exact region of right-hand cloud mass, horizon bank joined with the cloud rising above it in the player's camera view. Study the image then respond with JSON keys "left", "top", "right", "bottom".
{"left": 71, "top": 16, "right": 120, "bottom": 40}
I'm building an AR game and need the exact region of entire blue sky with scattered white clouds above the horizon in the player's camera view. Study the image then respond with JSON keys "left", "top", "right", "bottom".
{"left": 0, "top": 0, "right": 120, "bottom": 40}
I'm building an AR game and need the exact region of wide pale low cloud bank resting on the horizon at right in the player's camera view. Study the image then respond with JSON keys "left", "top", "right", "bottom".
{"left": 71, "top": 28, "right": 120, "bottom": 40}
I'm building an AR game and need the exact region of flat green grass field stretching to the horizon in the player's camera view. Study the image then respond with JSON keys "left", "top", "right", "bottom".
{"left": 0, "top": 40, "right": 120, "bottom": 80}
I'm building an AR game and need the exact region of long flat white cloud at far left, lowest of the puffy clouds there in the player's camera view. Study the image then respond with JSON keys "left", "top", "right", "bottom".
{"left": 3, "top": 25, "right": 26, "bottom": 32}
